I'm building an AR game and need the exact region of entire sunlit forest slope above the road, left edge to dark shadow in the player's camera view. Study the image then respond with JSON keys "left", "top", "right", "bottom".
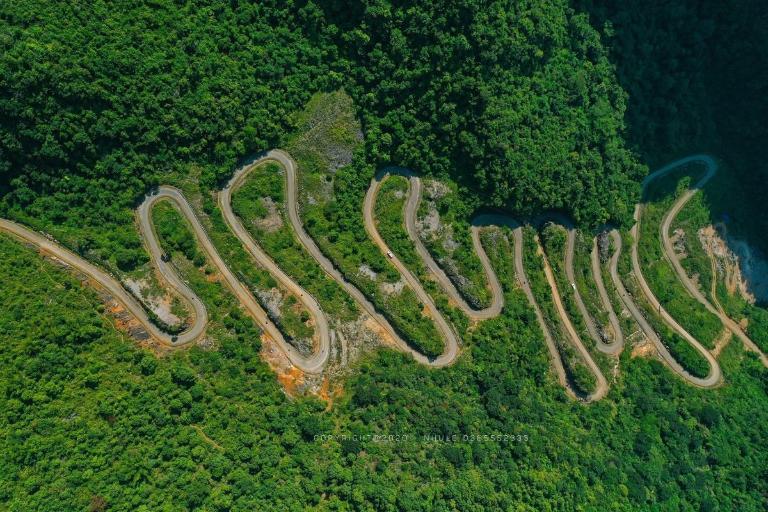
{"left": 0, "top": 0, "right": 642, "bottom": 248}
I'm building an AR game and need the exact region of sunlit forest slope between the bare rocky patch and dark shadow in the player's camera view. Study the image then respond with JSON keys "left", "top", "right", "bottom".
{"left": 325, "top": 1, "right": 644, "bottom": 224}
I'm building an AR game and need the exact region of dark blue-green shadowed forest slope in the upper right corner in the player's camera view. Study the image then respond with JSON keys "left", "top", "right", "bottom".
{"left": 576, "top": 0, "right": 768, "bottom": 253}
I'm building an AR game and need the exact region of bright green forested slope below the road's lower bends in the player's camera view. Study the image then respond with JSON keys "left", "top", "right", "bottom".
{"left": 0, "top": 236, "right": 768, "bottom": 511}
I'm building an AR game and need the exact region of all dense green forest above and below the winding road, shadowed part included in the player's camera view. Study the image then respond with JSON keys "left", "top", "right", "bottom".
{"left": 0, "top": 0, "right": 768, "bottom": 512}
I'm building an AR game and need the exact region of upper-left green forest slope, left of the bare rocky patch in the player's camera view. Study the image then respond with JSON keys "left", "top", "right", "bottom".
{"left": 0, "top": 1, "right": 337, "bottom": 260}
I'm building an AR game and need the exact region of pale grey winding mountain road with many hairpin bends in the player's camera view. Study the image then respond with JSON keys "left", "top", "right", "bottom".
{"left": 0, "top": 150, "right": 768, "bottom": 401}
